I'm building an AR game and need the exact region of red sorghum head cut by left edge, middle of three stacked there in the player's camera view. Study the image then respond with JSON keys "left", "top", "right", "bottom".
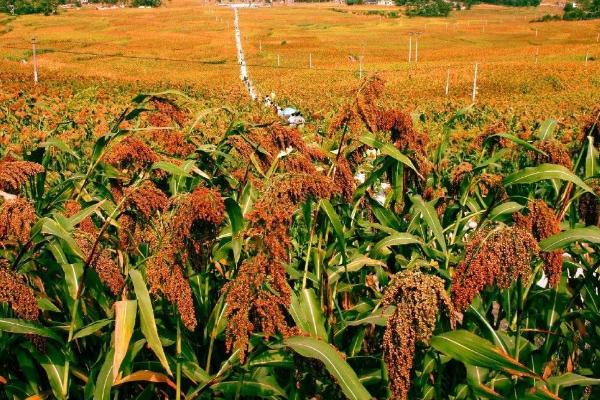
{"left": 0, "top": 197, "right": 36, "bottom": 244}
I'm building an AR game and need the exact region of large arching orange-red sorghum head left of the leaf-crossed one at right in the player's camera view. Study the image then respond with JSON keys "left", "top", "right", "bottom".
{"left": 452, "top": 225, "right": 539, "bottom": 311}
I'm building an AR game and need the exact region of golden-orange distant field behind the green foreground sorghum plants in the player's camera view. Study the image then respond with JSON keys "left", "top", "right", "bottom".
{"left": 0, "top": 0, "right": 600, "bottom": 123}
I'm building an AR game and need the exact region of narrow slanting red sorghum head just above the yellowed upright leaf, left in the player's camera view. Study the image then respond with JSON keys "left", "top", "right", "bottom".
{"left": 74, "top": 231, "right": 125, "bottom": 295}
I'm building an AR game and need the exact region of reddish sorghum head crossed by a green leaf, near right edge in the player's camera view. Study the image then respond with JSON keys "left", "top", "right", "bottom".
{"left": 514, "top": 200, "right": 562, "bottom": 286}
